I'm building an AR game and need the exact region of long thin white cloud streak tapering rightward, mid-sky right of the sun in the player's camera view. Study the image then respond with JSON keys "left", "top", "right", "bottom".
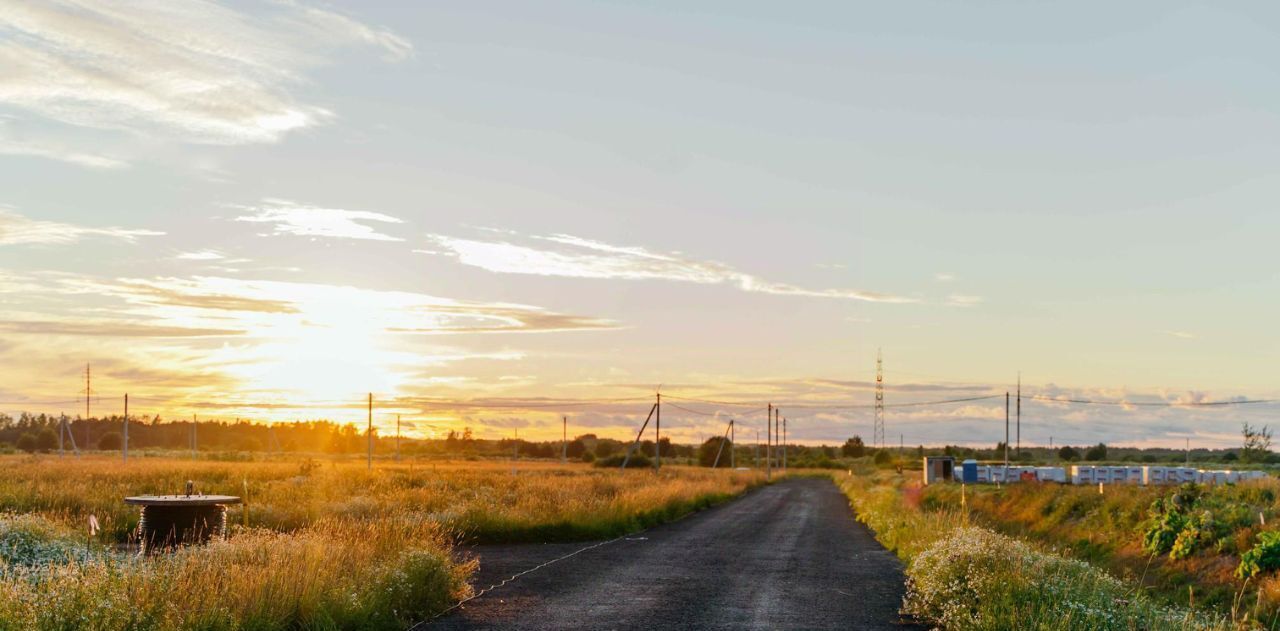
{"left": 420, "top": 234, "right": 916, "bottom": 302}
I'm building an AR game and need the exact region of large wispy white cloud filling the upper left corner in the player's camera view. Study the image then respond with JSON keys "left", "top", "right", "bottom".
{"left": 0, "top": 0, "right": 413, "bottom": 145}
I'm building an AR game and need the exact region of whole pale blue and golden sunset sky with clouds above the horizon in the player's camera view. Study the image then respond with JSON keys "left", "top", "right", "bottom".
{"left": 0, "top": 0, "right": 1280, "bottom": 447}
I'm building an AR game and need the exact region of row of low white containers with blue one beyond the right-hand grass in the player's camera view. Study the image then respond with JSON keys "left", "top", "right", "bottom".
{"left": 924, "top": 457, "right": 1267, "bottom": 485}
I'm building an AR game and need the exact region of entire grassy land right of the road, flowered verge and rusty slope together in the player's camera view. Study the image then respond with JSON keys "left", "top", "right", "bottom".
{"left": 837, "top": 470, "right": 1280, "bottom": 628}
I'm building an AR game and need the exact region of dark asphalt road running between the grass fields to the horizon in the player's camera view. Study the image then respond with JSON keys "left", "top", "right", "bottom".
{"left": 428, "top": 479, "right": 916, "bottom": 630}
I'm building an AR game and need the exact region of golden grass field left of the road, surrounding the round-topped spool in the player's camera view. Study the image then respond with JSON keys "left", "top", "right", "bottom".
{"left": 0, "top": 456, "right": 763, "bottom": 630}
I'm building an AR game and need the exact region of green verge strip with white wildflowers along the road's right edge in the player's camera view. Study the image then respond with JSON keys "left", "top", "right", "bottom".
{"left": 836, "top": 470, "right": 1228, "bottom": 630}
